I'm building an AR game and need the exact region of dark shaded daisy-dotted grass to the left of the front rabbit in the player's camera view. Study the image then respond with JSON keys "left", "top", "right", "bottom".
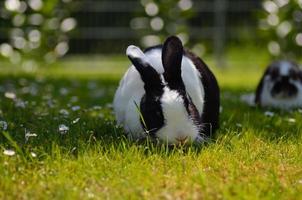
{"left": 0, "top": 73, "right": 210, "bottom": 158}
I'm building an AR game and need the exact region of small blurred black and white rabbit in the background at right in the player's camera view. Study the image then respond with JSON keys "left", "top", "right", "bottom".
{"left": 255, "top": 60, "right": 302, "bottom": 109}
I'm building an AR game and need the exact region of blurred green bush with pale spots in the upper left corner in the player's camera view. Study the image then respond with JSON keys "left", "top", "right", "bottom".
{"left": 0, "top": 0, "right": 76, "bottom": 70}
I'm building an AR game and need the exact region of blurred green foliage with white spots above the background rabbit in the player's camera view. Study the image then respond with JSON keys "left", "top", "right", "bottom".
{"left": 260, "top": 0, "right": 302, "bottom": 59}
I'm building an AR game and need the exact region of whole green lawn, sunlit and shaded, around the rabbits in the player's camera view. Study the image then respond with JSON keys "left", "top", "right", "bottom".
{"left": 0, "top": 48, "right": 302, "bottom": 199}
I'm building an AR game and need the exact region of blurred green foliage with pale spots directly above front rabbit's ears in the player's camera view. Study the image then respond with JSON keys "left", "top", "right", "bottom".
{"left": 130, "top": 0, "right": 194, "bottom": 47}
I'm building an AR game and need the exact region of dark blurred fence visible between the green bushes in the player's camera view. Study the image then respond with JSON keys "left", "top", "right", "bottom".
{"left": 70, "top": 0, "right": 261, "bottom": 55}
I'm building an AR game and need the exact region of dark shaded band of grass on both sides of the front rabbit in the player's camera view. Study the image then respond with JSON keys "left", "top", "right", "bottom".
{"left": 0, "top": 76, "right": 302, "bottom": 159}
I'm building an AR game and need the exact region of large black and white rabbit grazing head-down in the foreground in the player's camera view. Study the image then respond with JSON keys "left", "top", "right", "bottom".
{"left": 113, "top": 36, "right": 220, "bottom": 144}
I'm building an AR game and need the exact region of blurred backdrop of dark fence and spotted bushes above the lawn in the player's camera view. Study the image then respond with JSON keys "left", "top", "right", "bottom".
{"left": 0, "top": 0, "right": 302, "bottom": 70}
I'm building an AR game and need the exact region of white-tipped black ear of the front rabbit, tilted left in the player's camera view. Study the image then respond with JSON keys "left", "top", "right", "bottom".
{"left": 126, "top": 45, "right": 163, "bottom": 93}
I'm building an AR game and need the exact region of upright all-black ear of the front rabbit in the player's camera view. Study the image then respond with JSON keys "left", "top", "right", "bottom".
{"left": 162, "top": 36, "right": 183, "bottom": 89}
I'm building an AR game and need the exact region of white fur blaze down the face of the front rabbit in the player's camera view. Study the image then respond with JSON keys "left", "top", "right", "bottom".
{"left": 156, "top": 87, "right": 199, "bottom": 143}
